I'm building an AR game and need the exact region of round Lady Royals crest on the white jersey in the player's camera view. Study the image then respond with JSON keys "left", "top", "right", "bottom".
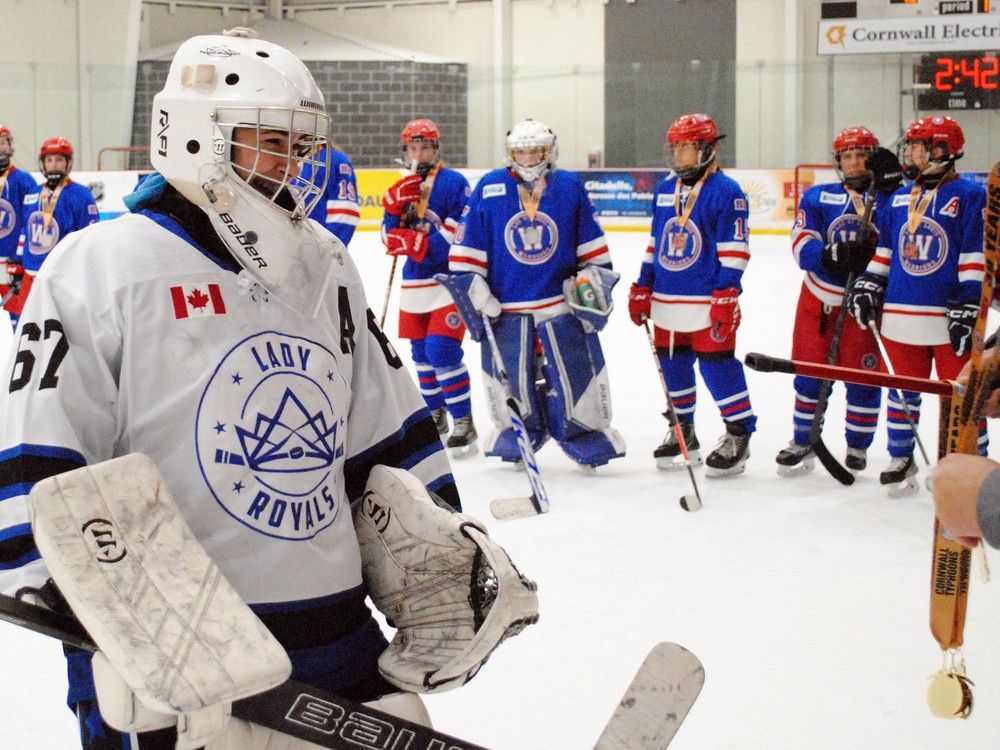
{"left": 195, "top": 331, "right": 348, "bottom": 541}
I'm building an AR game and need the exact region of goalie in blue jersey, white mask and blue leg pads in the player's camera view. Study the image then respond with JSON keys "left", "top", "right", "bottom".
{"left": 449, "top": 120, "right": 625, "bottom": 467}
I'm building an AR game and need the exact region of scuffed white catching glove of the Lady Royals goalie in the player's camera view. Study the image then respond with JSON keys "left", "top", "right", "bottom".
{"left": 354, "top": 466, "right": 538, "bottom": 692}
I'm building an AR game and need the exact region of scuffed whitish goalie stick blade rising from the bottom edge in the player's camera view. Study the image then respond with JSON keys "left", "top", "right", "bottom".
{"left": 594, "top": 642, "right": 705, "bottom": 750}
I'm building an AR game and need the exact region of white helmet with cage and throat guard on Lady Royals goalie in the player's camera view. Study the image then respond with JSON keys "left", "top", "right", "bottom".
{"left": 150, "top": 29, "right": 344, "bottom": 316}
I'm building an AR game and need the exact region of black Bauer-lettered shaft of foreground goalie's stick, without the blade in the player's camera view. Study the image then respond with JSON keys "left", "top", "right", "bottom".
{"left": 0, "top": 594, "right": 487, "bottom": 750}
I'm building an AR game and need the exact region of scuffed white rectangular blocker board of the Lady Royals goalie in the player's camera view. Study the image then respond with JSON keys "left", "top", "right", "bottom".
{"left": 31, "top": 453, "right": 291, "bottom": 714}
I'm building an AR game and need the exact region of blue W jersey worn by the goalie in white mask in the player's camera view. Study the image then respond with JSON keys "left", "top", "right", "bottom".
{"left": 449, "top": 169, "right": 611, "bottom": 320}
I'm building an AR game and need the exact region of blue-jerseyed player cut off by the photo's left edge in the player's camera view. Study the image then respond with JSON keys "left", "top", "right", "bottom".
{"left": 0, "top": 125, "right": 37, "bottom": 325}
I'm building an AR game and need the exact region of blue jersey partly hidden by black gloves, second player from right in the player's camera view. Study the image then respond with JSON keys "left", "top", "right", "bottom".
{"left": 792, "top": 182, "right": 889, "bottom": 307}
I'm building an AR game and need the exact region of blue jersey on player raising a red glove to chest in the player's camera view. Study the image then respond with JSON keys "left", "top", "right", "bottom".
{"left": 382, "top": 167, "right": 472, "bottom": 313}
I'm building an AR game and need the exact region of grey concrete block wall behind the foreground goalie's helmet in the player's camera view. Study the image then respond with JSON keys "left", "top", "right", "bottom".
{"left": 130, "top": 61, "right": 469, "bottom": 169}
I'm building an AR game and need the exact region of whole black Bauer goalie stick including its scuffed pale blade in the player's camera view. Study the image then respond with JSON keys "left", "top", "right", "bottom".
{"left": 0, "top": 594, "right": 705, "bottom": 750}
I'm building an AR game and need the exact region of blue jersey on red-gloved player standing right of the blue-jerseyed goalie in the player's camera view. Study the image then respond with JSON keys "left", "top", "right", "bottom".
{"left": 636, "top": 171, "right": 750, "bottom": 332}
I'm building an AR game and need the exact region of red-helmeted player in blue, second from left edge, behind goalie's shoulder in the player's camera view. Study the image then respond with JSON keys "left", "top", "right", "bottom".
{"left": 15, "top": 136, "right": 98, "bottom": 324}
